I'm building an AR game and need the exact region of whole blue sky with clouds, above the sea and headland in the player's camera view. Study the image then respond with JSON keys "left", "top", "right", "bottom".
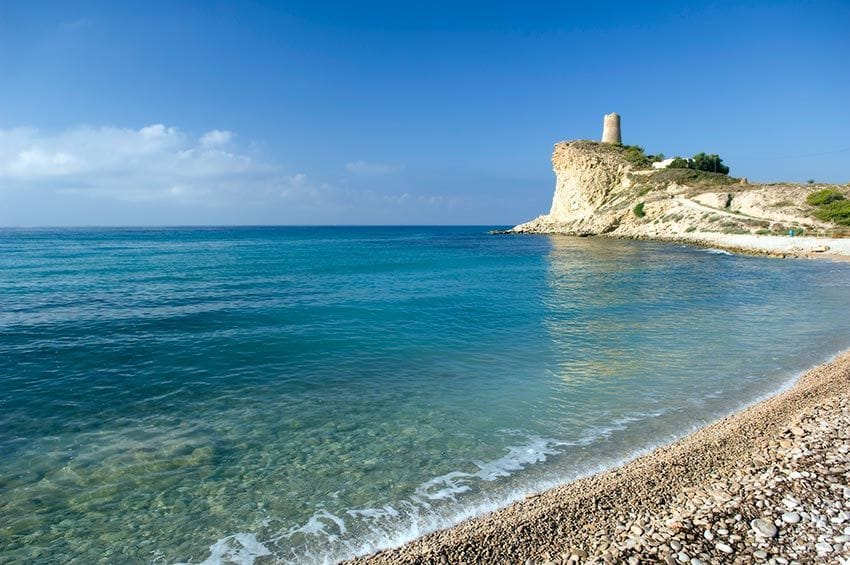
{"left": 0, "top": 0, "right": 850, "bottom": 226}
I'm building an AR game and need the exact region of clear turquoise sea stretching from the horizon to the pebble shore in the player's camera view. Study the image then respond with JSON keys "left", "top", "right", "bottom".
{"left": 0, "top": 227, "right": 850, "bottom": 563}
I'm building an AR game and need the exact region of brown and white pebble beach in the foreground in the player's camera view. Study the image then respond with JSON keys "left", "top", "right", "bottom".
{"left": 351, "top": 350, "right": 850, "bottom": 565}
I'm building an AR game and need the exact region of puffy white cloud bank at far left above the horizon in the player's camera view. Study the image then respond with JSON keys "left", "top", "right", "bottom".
{"left": 0, "top": 124, "right": 274, "bottom": 201}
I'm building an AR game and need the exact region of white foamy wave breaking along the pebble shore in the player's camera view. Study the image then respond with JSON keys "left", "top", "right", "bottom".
{"left": 195, "top": 411, "right": 680, "bottom": 565}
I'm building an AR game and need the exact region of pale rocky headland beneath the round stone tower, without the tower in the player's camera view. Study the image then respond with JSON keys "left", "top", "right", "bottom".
{"left": 506, "top": 140, "right": 850, "bottom": 257}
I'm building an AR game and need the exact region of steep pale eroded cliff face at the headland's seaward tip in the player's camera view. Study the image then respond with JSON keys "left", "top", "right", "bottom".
{"left": 514, "top": 141, "right": 631, "bottom": 235}
